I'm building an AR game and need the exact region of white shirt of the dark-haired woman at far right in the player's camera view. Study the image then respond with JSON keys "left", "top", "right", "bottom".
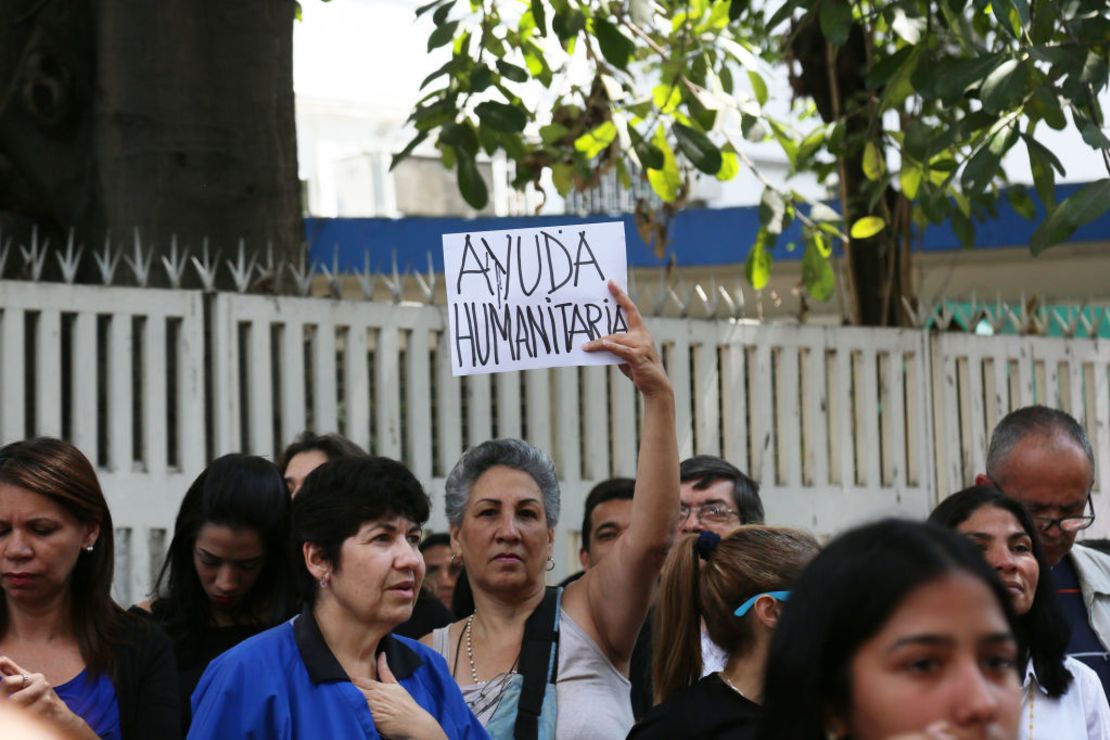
{"left": 1018, "top": 658, "right": 1110, "bottom": 740}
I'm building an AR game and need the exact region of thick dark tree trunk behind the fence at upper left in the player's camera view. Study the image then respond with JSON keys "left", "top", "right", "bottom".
{"left": 0, "top": 0, "right": 303, "bottom": 284}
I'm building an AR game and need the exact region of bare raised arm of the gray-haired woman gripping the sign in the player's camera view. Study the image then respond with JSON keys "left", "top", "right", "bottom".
{"left": 564, "top": 283, "right": 679, "bottom": 670}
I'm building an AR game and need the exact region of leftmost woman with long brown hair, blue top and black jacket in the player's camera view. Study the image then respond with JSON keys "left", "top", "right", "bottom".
{"left": 0, "top": 438, "right": 180, "bottom": 740}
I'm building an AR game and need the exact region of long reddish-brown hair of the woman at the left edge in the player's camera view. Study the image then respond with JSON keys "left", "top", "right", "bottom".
{"left": 0, "top": 437, "right": 123, "bottom": 675}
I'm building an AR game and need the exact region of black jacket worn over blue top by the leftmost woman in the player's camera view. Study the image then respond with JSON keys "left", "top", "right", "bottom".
{"left": 112, "top": 614, "right": 181, "bottom": 740}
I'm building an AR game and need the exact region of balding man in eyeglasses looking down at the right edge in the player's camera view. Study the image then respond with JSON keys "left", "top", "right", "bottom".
{"left": 976, "top": 406, "right": 1110, "bottom": 695}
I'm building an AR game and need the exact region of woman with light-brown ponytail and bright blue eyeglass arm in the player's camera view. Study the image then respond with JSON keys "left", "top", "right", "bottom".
{"left": 628, "top": 525, "right": 819, "bottom": 740}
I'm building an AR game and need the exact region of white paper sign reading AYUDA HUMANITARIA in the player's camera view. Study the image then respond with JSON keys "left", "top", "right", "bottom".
{"left": 443, "top": 221, "right": 628, "bottom": 375}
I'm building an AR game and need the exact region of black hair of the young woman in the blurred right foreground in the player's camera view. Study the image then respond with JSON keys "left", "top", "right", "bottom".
{"left": 758, "top": 519, "right": 1015, "bottom": 740}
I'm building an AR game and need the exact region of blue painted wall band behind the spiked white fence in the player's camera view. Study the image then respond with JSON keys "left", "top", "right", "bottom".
{"left": 305, "top": 185, "right": 1110, "bottom": 272}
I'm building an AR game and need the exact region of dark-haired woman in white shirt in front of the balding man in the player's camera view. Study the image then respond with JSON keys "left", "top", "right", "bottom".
{"left": 929, "top": 486, "right": 1110, "bottom": 740}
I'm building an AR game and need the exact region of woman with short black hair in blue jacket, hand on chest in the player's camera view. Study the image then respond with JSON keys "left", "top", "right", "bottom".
{"left": 189, "top": 457, "right": 487, "bottom": 740}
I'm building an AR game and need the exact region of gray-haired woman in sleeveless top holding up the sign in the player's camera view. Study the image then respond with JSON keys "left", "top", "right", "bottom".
{"left": 424, "top": 283, "right": 678, "bottom": 740}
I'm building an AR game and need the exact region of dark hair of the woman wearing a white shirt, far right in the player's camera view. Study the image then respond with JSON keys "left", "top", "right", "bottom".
{"left": 929, "top": 486, "right": 1072, "bottom": 698}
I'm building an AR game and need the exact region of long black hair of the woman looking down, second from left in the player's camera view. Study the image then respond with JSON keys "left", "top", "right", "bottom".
{"left": 152, "top": 455, "right": 293, "bottom": 655}
